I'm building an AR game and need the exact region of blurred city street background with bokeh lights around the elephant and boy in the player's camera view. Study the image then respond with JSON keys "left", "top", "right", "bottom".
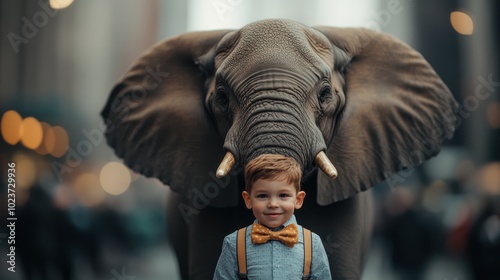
{"left": 0, "top": 0, "right": 500, "bottom": 280}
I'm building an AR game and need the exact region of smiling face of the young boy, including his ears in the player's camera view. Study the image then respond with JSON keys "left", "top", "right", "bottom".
{"left": 242, "top": 179, "right": 306, "bottom": 228}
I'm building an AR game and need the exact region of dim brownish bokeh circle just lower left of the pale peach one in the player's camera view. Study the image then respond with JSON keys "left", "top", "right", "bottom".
{"left": 73, "top": 173, "right": 105, "bottom": 207}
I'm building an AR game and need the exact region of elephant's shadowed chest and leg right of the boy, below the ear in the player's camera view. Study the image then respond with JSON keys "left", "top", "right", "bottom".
{"left": 296, "top": 189, "right": 374, "bottom": 279}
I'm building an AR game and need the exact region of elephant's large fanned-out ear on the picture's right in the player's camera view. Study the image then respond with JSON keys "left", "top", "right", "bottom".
{"left": 317, "top": 27, "right": 457, "bottom": 205}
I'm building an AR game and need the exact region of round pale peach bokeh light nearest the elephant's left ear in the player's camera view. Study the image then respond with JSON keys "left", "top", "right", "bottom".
{"left": 99, "top": 161, "right": 132, "bottom": 195}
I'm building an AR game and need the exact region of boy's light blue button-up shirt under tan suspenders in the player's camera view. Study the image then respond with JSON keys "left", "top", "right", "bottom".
{"left": 214, "top": 216, "right": 332, "bottom": 280}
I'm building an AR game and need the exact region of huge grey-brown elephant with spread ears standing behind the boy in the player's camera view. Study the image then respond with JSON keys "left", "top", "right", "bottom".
{"left": 101, "top": 19, "right": 457, "bottom": 279}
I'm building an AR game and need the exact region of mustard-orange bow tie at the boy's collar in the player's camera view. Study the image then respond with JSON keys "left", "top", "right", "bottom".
{"left": 250, "top": 223, "right": 299, "bottom": 247}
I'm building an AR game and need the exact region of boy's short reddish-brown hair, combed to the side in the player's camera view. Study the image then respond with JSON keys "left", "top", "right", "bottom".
{"left": 245, "top": 154, "right": 302, "bottom": 192}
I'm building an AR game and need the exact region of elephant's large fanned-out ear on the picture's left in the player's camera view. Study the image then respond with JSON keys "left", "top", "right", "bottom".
{"left": 101, "top": 31, "right": 238, "bottom": 208}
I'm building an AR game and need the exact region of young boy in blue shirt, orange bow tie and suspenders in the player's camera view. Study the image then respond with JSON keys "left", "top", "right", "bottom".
{"left": 214, "top": 154, "right": 331, "bottom": 280}
